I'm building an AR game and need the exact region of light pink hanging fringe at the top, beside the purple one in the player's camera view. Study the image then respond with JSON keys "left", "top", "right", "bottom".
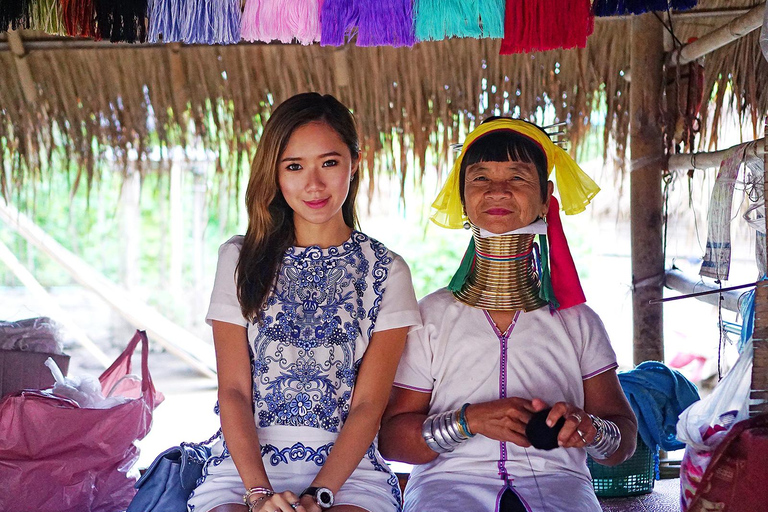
{"left": 241, "top": 0, "right": 320, "bottom": 45}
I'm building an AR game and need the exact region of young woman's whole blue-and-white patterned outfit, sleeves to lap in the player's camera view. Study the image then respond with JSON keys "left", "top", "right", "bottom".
{"left": 188, "top": 231, "right": 421, "bottom": 512}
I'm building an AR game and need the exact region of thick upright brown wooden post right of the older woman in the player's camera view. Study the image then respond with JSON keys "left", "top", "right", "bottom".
{"left": 629, "top": 13, "right": 664, "bottom": 364}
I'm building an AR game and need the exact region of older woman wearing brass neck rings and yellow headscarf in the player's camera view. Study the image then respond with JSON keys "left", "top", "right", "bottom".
{"left": 379, "top": 118, "right": 637, "bottom": 512}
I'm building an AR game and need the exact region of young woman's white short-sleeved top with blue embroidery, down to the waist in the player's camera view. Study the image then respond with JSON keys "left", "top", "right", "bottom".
{"left": 206, "top": 231, "right": 421, "bottom": 433}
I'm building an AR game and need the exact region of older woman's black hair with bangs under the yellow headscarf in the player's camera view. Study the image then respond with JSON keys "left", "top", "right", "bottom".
{"left": 459, "top": 116, "right": 549, "bottom": 204}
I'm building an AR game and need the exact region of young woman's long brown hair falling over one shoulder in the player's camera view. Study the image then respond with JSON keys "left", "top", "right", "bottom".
{"left": 236, "top": 92, "right": 360, "bottom": 322}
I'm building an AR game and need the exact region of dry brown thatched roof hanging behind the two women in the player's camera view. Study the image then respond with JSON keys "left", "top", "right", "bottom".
{"left": 0, "top": 0, "right": 768, "bottom": 200}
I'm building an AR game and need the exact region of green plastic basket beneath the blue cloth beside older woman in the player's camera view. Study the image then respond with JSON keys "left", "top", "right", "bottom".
{"left": 587, "top": 436, "right": 655, "bottom": 498}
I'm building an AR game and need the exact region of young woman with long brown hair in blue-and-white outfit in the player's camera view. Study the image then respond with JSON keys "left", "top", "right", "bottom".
{"left": 188, "top": 93, "right": 421, "bottom": 512}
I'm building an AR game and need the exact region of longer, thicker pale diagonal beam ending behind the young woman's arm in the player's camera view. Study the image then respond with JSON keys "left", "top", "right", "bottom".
{"left": 0, "top": 201, "right": 216, "bottom": 378}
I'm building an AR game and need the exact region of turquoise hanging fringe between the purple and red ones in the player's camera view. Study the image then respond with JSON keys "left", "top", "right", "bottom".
{"left": 413, "top": 0, "right": 504, "bottom": 41}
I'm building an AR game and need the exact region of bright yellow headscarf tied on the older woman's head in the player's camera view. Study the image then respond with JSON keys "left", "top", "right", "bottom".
{"left": 430, "top": 119, "right": 600, "bottom": 229}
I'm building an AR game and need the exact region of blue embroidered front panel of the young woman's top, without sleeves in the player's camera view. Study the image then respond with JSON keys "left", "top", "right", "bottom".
{"left": 251, "top": 231, "right": 392, "bottom": 432}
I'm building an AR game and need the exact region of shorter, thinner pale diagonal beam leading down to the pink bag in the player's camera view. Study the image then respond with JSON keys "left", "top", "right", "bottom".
{"left": 0, "top": 241, "right": 112, "bottom": 369}
